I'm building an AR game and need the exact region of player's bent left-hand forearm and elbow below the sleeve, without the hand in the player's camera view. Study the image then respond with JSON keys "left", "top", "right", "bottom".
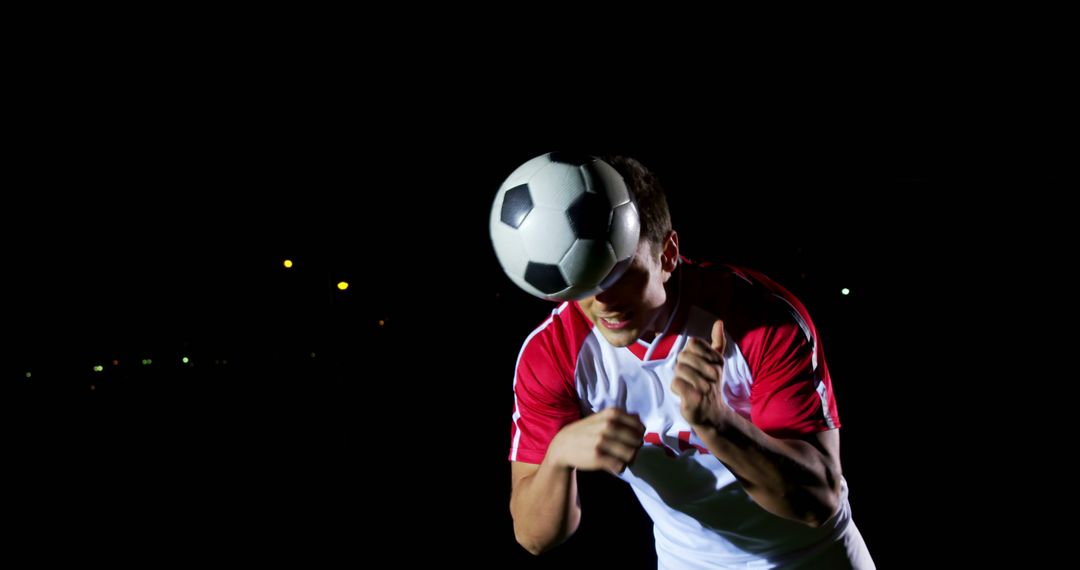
{"left": 510, "top": 460, "right": 581, "bottom": 554}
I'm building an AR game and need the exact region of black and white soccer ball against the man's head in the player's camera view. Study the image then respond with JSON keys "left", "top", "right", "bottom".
{"left": 490, "top": 152, "right": 640, "bottom": 300}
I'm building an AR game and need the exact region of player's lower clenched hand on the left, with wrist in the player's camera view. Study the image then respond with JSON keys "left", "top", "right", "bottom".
{"left": 548, "top": 408, "right": 645, "bottom": 474}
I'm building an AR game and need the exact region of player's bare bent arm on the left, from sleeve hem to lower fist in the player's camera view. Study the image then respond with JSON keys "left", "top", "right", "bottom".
{"left": 510, "top": 408, "right": 645, "bottom": 554}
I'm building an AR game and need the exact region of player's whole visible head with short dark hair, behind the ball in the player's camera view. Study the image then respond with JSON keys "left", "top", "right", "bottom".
{"left": 579, "top": 157, "right": 678, "bottom": 347}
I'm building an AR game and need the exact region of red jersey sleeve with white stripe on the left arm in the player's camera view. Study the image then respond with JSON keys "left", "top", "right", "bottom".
{"left": 510, "top": 319, "right": 581, "bottom": 463}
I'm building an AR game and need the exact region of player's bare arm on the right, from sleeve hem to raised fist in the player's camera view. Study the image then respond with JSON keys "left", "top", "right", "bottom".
{"left": 672, "top": 321, "right": 840, "bottom": 527}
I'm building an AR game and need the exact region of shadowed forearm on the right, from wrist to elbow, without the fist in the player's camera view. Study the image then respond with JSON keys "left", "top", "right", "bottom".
{"left": 693, "top": 413, "right": 840, "bottom": 526}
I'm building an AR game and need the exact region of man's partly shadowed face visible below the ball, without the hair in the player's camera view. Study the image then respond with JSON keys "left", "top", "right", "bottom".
{"left": 578, "top": 240, "right": 678, "bottom": 347}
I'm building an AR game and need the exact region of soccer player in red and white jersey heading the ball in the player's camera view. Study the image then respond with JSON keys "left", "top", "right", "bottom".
{"left": 510, "top": 157, "right": 874, "bottom": 569}
